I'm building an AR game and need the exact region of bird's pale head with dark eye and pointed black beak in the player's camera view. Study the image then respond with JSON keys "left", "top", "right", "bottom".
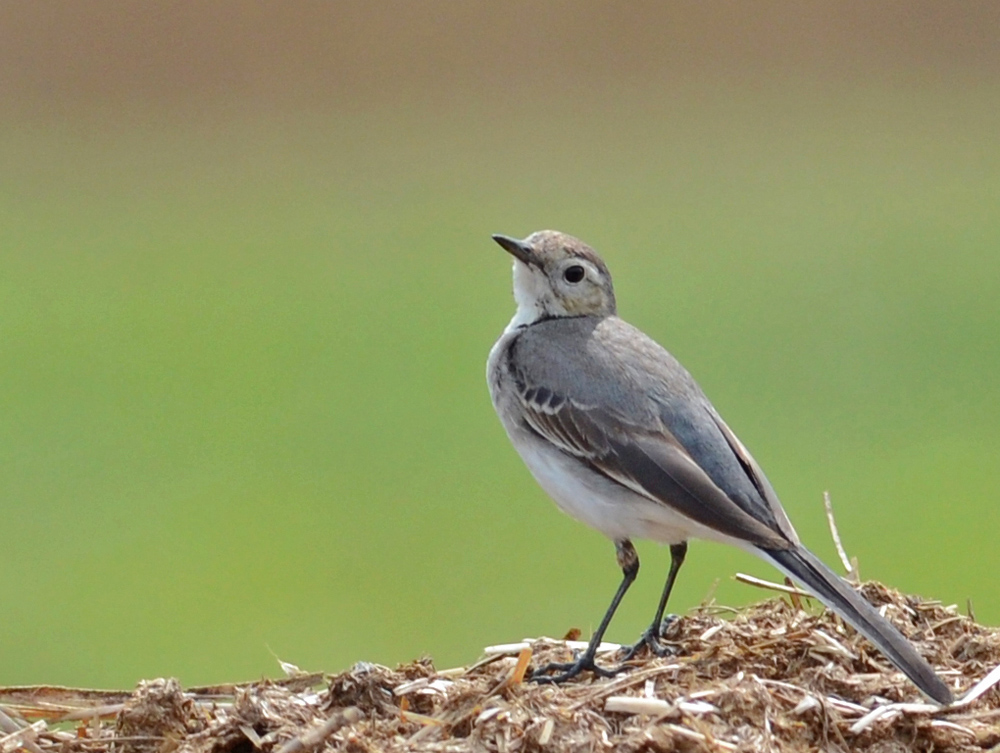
{"left": 493, "top": 230, "right": 616, "bottom": 326}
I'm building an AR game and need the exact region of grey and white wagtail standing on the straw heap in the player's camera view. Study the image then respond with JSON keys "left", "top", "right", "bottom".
{"left": 486, "top": 230, "right": 952, "bottom": 704}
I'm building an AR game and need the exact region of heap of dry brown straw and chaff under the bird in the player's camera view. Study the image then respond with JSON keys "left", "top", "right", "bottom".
{"left": 0, "top": 583, "right": 1000, "bottom": 753}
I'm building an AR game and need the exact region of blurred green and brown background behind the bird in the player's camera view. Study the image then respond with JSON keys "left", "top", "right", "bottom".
{"left": 0, "top": 2, "right": 1000, "bottom": 687}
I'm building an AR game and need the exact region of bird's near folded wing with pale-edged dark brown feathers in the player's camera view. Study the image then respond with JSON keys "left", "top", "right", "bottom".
{"left": 515, "top": 372, "right": 792, "bottom": 549}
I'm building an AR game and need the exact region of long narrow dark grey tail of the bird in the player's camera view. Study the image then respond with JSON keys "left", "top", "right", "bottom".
{"left": 757, "top": 547, "right": 954, "bottom": 705}
